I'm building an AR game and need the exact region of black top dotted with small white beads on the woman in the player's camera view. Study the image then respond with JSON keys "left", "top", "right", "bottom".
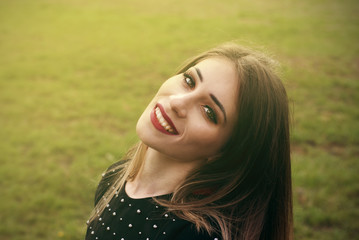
{"left": 85, "top": 163, "right": 220, "bottom": 240}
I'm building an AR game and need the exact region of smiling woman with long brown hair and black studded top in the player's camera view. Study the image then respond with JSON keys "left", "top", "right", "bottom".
{"left": 86, "top": 44, "right": 292, "bottom": 240}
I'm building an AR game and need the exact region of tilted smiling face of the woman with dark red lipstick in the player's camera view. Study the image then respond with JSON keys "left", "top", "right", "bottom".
{"left": 136, "top": 57, "right": 239, "bottom": 161}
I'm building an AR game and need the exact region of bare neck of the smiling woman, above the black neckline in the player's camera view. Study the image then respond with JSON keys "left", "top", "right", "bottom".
{"left": 125, "top": 148, "right": 203, "bottom": 198}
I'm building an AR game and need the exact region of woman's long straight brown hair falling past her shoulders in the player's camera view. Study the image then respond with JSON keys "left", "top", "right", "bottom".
{"left": 91, "top": 44, "right": 293, "bottom": 240}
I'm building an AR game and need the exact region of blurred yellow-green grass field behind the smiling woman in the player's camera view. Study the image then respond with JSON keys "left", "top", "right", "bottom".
{"left": 0, "top": 0, "right": 359, "bottom": 240}
